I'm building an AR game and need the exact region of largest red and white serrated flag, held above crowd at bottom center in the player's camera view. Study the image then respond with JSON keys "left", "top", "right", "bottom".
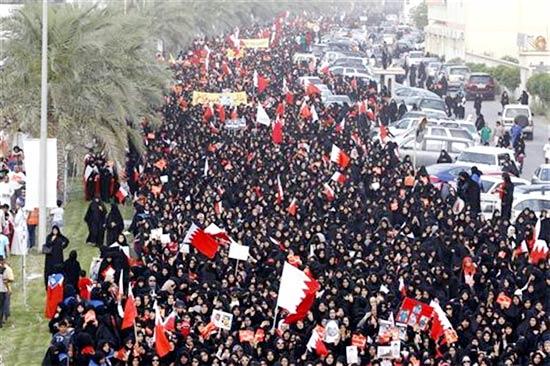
{"left": 277, "top": 262, "right": 319, "bottom": 323}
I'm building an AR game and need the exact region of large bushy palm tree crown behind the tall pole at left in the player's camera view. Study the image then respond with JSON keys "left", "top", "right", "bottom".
{"left": 0, "top": 5, "right": 170, "bottom": 172}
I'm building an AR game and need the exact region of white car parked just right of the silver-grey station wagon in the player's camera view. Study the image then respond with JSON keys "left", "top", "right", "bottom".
{"left": 456, "top": 146, "right": 518, "bottom": 172}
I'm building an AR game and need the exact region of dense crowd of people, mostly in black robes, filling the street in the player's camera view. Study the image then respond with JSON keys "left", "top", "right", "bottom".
{"left": 44, "top": 12, "right": 550, "bottom": 366}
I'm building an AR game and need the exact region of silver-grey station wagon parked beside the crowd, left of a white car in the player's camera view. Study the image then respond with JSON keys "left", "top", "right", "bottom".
{"left": 396, "top": 131, "right": 475, "bottom": 166}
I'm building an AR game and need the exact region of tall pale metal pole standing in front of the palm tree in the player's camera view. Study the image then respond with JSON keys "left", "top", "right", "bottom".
{"left": 38, "top": 0, "right": 48, "bottom": 251}
